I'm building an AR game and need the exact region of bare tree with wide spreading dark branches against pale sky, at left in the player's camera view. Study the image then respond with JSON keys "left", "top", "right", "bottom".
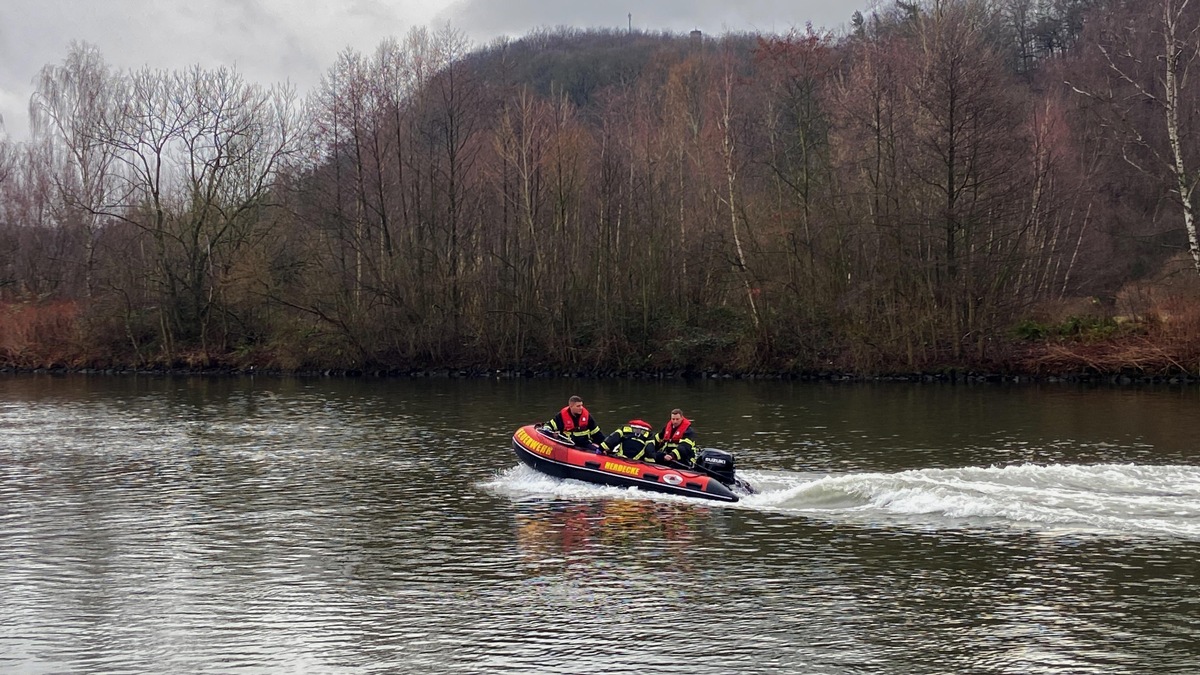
{"left": 101, "top": 67, "right": 301, "bottom": 356}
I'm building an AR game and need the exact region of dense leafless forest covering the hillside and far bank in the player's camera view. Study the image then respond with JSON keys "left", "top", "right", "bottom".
{"left": 0, "top": 0, "right": 1200, "bottom": 375}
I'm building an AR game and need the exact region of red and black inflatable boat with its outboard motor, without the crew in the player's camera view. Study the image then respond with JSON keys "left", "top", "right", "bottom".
{"left": 512, "top": 424, "right": 752, "bottom": 502}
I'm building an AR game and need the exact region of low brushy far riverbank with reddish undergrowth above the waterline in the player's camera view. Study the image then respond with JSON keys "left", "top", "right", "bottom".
{"left": 9, "top": 289, "right": 1200, "bottom": 384}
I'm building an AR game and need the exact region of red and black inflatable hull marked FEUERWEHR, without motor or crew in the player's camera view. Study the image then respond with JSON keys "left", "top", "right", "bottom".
{"left": 512, "top": 424, "right": 738, "bottom": 502}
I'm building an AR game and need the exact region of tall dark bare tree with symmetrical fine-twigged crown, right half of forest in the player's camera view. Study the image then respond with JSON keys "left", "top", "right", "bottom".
{"left": 906, "top": 0, "right": 1024, "bottom": 358}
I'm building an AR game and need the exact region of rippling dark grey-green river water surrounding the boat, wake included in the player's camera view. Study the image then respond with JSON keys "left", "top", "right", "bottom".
{"left": 0, "top": 375, "right": 1200, "bottom": 675}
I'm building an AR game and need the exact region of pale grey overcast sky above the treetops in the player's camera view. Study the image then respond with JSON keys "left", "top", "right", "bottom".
{"left": 0, "top": 0, "right": 869, "bottom": 141}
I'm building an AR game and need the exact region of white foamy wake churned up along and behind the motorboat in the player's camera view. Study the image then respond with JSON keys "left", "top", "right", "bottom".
{"left": 487, "top": 464, "right": 1200, "bottom": 540}
